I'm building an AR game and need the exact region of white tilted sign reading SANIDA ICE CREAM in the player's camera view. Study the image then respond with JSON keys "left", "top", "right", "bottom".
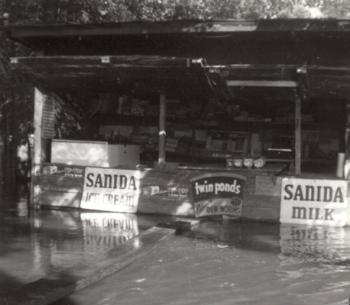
{"left": 81, "top": 167, "right": 141, "bottom": 213}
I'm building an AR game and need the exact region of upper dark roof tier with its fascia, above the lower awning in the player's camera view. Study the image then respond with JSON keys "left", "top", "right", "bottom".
{"left": 2, "top": 19, "right": 350, "bottom": 66}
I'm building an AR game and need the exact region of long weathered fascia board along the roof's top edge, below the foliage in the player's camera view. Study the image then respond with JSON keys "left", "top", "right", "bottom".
{"left": 6, "top": 19, "right": 350, "bottom": 42}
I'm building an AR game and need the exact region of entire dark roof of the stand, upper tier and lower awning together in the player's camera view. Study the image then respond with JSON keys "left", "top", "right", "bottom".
{"left": 2, "top": 19, "right": 350, "bottom": 98}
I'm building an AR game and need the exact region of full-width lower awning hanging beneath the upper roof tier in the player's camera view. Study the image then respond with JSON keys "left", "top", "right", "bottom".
{"left": 11, "top": 55, "right": 350, "bottom": 98}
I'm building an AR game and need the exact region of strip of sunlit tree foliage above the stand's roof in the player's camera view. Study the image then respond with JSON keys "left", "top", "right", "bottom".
{"left": 0, "top": 0, "right": 350, "bottom": 24}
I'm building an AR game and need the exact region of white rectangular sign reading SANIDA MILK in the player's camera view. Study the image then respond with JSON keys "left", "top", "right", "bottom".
{"left": 280, "top": 178, "right": 349, "bottom": 226}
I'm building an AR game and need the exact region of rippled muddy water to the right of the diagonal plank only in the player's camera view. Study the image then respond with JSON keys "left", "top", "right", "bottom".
{"left": 55, "top": 217, "right": 350, "bottom": 305}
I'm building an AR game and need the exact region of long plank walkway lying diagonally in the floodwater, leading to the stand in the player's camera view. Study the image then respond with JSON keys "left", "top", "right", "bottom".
{"left": 0, "top": 227, "right": 175, "bottom": 305}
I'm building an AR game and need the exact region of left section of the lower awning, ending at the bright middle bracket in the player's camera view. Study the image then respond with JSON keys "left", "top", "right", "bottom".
{"left": 11, "top": 55, "right": 212, "bottom": 97}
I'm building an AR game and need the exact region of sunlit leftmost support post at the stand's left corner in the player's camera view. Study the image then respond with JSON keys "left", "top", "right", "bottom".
{"left": 30, "top": 88, "right": 47, "bottom": 208}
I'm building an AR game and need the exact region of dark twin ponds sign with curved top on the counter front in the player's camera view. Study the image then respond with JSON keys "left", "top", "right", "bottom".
{"left": 191, "top": 173, "right": 246, "bottom": 217}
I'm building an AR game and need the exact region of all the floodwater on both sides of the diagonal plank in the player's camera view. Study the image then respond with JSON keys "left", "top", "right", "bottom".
{"left": 0, "top": 198, "right": 350, "bottom": 305}
